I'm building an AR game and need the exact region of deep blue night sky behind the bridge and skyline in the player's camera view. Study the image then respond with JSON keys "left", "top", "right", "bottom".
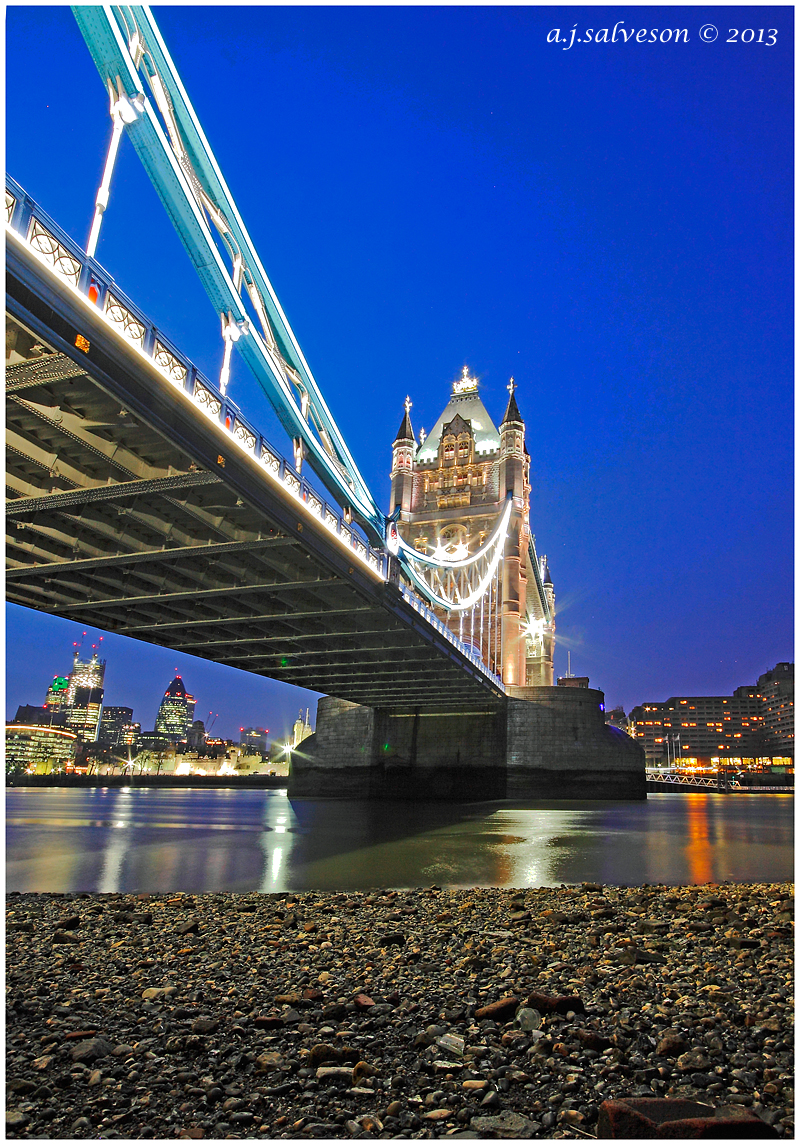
{"left": 7, "top": 7, "right": 793, "bottom": 735}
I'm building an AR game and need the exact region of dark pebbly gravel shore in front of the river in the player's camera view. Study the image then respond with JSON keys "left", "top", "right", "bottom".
{"left": 6, "top": 883, "right": 794, "bottom": 1139}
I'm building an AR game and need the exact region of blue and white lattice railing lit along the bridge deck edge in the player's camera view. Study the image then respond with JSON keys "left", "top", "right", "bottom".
{"left": 6, "top": 175, "right": 502, "bottom": 688}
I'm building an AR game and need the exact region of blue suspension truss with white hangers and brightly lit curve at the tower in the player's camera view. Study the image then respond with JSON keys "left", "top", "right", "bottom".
{"left": 67, "top": 5, "right": 526, "bottom": 654}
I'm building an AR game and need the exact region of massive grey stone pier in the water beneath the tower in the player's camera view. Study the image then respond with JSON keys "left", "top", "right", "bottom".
{"left": 288, "top": 687, "right": 647, "bottom": 802}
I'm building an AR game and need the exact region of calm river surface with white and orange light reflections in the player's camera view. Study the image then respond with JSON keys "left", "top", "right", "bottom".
{"left": 6, "top": 788, "right": 794, "bottom": 892}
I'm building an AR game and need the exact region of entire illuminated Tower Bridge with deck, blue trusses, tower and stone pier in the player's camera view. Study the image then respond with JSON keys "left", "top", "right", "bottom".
{"left": 6, "top": 7, "right": 644, "bottom": 798}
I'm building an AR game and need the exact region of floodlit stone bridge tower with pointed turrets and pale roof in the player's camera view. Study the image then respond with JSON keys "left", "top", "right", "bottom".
{"left": 389, "top": 366, "right": 555, "bottom": 687}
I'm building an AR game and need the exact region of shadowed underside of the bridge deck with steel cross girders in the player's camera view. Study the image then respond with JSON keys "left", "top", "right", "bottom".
{"left": 6, "top": 253, "right": 504, "bottom": 711}
